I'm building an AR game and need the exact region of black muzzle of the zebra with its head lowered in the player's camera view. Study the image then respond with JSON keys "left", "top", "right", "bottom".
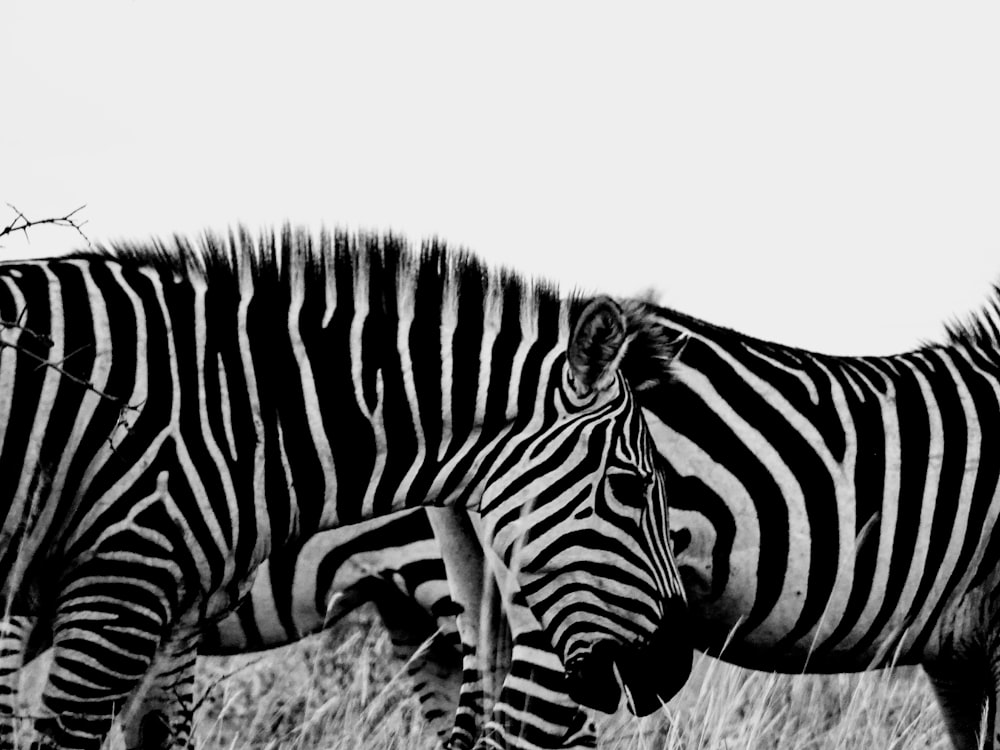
{"left": 566, "top": 603, "right": 694, "bottom": 716}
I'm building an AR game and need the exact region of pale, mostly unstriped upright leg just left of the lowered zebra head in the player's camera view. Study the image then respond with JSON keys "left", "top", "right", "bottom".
{"left": 427, "top": 508, "right": 498, "bottom": 750}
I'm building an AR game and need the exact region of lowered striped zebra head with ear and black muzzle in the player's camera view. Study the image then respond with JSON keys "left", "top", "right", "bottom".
{"left": 472, "top": 298, "right": 691, "bottom": 715}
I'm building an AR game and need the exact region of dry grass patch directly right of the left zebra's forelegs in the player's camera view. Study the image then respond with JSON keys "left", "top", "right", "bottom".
{"left": 191, "top": 618, "right": 436, "bottom": 750}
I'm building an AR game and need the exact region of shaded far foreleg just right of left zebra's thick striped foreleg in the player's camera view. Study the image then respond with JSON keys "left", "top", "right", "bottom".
{"left": 120, "top": 620, "right": 200, "bottom": 750}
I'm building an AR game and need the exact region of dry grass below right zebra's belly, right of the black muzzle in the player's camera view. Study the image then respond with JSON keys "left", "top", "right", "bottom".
{"left": 602, "top": 657, "right": 951, "bottom": 750}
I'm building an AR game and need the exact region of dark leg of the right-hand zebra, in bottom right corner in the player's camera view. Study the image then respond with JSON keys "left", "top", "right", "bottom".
{"left": 924, "top": 660, "right": 1000, "bottom": 750}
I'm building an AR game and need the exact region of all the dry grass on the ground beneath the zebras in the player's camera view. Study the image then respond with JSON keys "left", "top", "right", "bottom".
{"left": 13, "top": 610, "right": 950, "bottom": 750}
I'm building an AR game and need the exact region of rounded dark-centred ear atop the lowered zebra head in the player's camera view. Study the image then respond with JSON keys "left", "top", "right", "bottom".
{"left": 566, "top": 297, "right": 627, "bottom": 396}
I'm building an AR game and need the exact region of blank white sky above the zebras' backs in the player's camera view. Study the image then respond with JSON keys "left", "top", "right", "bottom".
{"left": 0, "top": 0, "right": 1000, "bottom": 353}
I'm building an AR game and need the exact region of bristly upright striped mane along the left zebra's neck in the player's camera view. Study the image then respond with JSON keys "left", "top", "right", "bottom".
{"left": 70, "top": 224, "right": 579, "bottom": 324}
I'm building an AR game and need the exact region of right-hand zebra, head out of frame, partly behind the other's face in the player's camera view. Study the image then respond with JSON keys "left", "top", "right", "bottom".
{"left": 348, "top": 286, "right": 1000, "bottom": 750}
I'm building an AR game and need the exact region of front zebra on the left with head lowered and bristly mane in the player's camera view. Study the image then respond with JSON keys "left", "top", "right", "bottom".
{"left": 0, "top": 227, "right": 691, "bottom": 749}
